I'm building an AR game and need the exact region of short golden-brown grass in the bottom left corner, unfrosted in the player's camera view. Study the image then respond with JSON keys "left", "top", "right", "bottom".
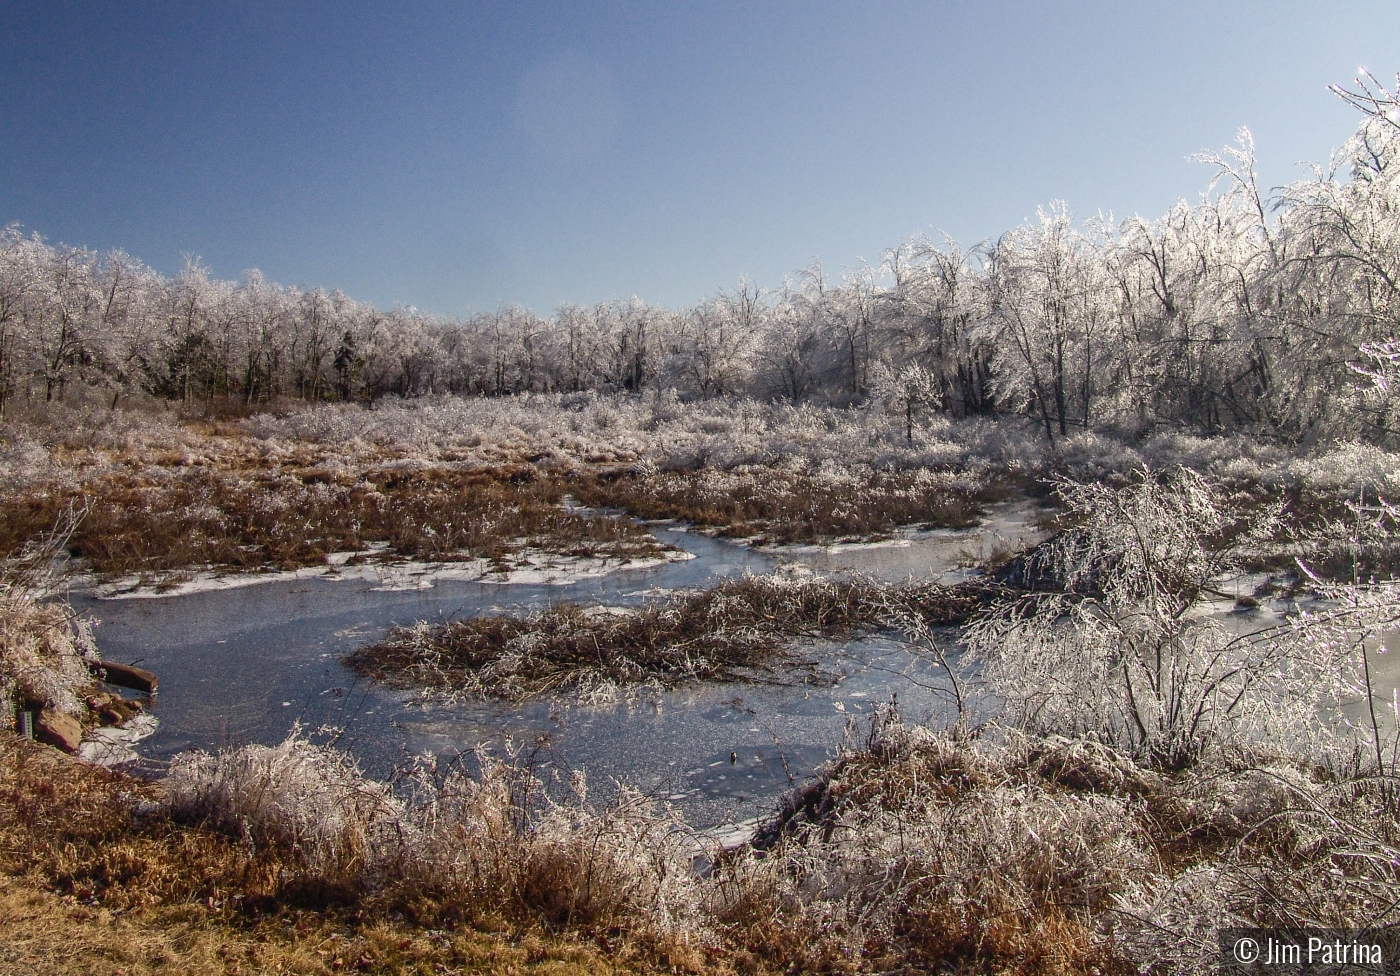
{"left": 0, "top": 735, "right": 706, "bottom": 976}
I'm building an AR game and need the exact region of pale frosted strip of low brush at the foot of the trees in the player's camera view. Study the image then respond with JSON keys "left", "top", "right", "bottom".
{"left": 229, "top": 393, "right": 1400, "bottom": 499}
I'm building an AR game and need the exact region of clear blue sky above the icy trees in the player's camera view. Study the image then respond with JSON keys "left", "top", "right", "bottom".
{"left": 0, "top": 0, "right": 1400, "bottom": 314}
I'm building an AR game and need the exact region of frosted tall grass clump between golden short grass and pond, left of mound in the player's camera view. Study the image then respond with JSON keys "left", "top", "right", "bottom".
{"left": 162, "top": 731, "right": 699, "bottom": 933}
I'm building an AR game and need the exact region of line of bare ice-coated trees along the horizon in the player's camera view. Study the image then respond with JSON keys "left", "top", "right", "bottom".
{"left": 0, "top": 76, "right": 1400, "bottom": 441}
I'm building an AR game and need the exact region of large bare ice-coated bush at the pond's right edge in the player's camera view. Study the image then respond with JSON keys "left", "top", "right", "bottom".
{"left": 969, "top": 470, "right": 1364, "bottom": 767}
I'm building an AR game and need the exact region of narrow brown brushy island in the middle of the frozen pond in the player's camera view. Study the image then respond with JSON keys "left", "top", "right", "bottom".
{"left": 346, "top": 574, "right": 1002, "bottom": 700}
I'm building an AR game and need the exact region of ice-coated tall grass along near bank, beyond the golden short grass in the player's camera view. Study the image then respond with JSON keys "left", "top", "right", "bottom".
{"left": 136, "top": 707, "right": 1400, "bottom": 973}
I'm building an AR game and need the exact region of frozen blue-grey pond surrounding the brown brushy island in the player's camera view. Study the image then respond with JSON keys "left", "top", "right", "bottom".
{"left": 73, "top": 506, "right": 1047, "bottom": 826}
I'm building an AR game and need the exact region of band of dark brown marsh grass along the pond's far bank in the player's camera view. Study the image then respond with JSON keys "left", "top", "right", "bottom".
{"left": 0, "top": 453, "right": 979, "bottom": 577}
